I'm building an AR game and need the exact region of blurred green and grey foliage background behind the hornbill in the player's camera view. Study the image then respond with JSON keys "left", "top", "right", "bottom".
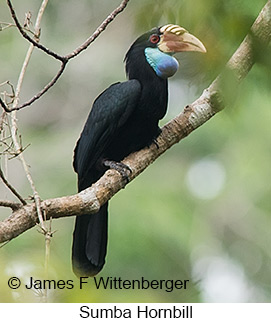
{"left": 0, "top": 0, "right": 271, "bottom": 302}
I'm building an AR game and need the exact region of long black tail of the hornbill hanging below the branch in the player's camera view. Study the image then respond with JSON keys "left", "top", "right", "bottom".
{"left": 72, "top": 203, "right": 108, "bottom": 277}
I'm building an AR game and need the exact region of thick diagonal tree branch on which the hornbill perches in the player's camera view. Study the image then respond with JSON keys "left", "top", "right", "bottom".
{"left": 0, "top": 0, "right": 271, "bottom": 242}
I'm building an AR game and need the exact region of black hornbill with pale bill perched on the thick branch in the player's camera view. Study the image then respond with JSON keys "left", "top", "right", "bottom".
{"left": 72, "top": 24, "right": 206, "bottom": 276}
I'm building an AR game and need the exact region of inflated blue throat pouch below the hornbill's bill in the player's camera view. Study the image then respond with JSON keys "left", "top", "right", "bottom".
{"left": 145, "top": 47, "right": 179, "bottom": 79}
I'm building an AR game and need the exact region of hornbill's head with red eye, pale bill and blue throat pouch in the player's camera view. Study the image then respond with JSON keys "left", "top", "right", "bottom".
{"left": 126, "top": 24, "right": 206, "bottom": 79}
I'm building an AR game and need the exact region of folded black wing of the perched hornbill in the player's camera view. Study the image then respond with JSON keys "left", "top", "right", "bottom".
{"left": 73, "top": 80, "right": 141, "bottom": 184}
